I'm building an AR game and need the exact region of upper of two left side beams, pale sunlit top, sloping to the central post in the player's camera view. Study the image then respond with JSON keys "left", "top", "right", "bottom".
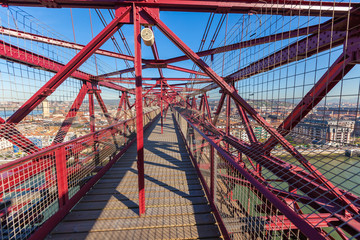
{"left": 0, "top": 26, "right": 137, "bottom": 62}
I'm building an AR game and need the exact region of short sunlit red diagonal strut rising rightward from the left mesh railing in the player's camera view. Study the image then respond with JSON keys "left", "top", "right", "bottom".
{"left": 51, "top": 83, "right": 88, "bottom": 145}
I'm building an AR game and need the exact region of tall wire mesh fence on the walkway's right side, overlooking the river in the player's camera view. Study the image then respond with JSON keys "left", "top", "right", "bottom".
{"left": 179, "top": 1, "right": 360, "bottom": 239}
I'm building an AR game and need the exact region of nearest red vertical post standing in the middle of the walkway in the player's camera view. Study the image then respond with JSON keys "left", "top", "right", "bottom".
{"left": 133, "top": 4, "right": 145, "bottom": 216}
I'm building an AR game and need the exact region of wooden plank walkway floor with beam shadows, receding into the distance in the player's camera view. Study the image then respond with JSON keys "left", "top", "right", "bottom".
{"left": 48, "top": 115, "right": 220, "bottom": 240}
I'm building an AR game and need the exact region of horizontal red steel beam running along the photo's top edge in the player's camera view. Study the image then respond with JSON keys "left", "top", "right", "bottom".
{"left": 0, "top": 0, "right": 356, "bottom": 17}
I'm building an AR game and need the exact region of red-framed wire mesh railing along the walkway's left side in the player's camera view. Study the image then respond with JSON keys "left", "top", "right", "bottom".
{"left": 0, "top": 107, "right": 159, "bottom": 239}
